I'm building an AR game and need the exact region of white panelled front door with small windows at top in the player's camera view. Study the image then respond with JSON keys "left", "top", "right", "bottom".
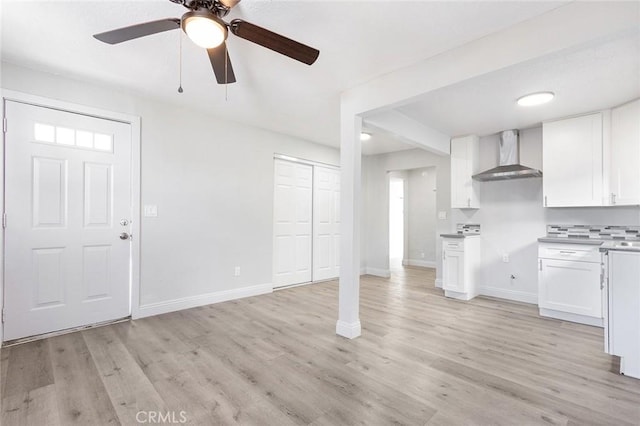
{"left": 4, "top": 101, "right": 131, "bottom": 340}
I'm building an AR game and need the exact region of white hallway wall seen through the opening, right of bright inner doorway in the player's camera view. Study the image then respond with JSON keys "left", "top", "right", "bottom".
{"left": 404, "top": 167, "right": 446, "bottom": 267}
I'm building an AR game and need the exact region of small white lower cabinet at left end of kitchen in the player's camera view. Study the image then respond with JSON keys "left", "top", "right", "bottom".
{"left": 442, "top": 236, "right": 480, "bottom": 300}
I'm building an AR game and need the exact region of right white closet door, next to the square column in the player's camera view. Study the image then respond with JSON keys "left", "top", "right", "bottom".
{"left": 313, "top": 166, "right": 340, "bottom": 281}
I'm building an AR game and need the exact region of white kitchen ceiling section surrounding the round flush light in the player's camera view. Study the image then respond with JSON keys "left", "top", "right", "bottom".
{"left": 398, "top": 28, "right": 640, "bottom": 136}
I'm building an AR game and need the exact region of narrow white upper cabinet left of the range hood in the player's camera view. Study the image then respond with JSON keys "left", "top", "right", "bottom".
{"left": 451, "top": 135, "right": 480, "bottom": 209}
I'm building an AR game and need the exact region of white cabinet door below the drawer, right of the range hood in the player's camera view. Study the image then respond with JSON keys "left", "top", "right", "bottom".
{"left": 538, "top": 259, "right": 602, "bottom": 318}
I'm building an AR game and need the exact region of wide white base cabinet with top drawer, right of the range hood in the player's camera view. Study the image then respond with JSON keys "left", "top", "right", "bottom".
{"left": 538, "top": 244, "right": 603, "bottom": 326}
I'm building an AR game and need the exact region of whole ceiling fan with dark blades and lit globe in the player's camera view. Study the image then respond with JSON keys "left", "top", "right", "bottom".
{"left": 94, "top": 0, "right": 320, "bottom": 84}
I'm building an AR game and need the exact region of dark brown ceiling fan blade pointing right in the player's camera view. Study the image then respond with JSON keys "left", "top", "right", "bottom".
{"left": 230, "top": 19, "right": 320, "bottom": 65}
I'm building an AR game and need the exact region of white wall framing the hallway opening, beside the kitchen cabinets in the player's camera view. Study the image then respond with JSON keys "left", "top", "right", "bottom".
{"left": 361, "top": 149, "right": 451, "bottom": 276}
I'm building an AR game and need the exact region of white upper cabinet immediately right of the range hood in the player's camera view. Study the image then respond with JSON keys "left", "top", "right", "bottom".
{"left": 542, "top": 112, "right": 603, "bottom": 207}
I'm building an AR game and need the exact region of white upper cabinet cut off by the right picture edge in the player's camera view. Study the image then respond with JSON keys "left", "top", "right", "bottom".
{"left": 609, "top": 99, "right": 640, "bottom": 206}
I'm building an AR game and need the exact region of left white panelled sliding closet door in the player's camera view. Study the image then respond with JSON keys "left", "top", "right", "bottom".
{"left": 273, "top": 160, "right": 313, "bottom": 287}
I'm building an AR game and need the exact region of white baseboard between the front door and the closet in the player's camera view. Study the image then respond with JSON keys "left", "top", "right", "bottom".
{"left": 133, "top": 283, "right": 273, "bottom": 319}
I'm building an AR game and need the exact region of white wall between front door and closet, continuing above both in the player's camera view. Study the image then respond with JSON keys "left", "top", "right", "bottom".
{"left": 1, "top": 63, "right": 339, "bottom": 314}
